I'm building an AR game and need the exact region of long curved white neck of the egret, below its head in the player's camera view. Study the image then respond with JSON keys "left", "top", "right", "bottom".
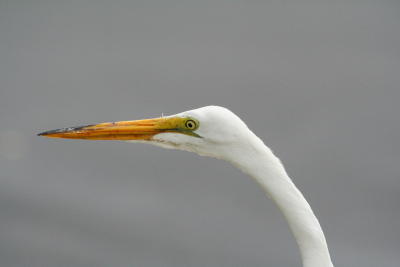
{"left": 228, "top": 136, "right": 333, "bottom": 267}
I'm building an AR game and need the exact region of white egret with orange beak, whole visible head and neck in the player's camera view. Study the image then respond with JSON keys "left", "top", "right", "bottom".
{"left": 39, "top": 106, "right": 333, "bottom": 267}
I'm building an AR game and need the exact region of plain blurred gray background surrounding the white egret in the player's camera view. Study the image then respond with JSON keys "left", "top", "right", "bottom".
{"left": 0, "top": 0, "right": 400, "bottom": 267}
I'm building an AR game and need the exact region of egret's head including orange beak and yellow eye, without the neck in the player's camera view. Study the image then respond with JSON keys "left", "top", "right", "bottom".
{"left": 39, "top": 106, "right": 251, "bottom": 161}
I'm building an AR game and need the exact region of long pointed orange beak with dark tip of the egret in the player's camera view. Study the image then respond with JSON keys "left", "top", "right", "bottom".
{"left": 38, "top": 118, "right": 181, "bottom": 140}
